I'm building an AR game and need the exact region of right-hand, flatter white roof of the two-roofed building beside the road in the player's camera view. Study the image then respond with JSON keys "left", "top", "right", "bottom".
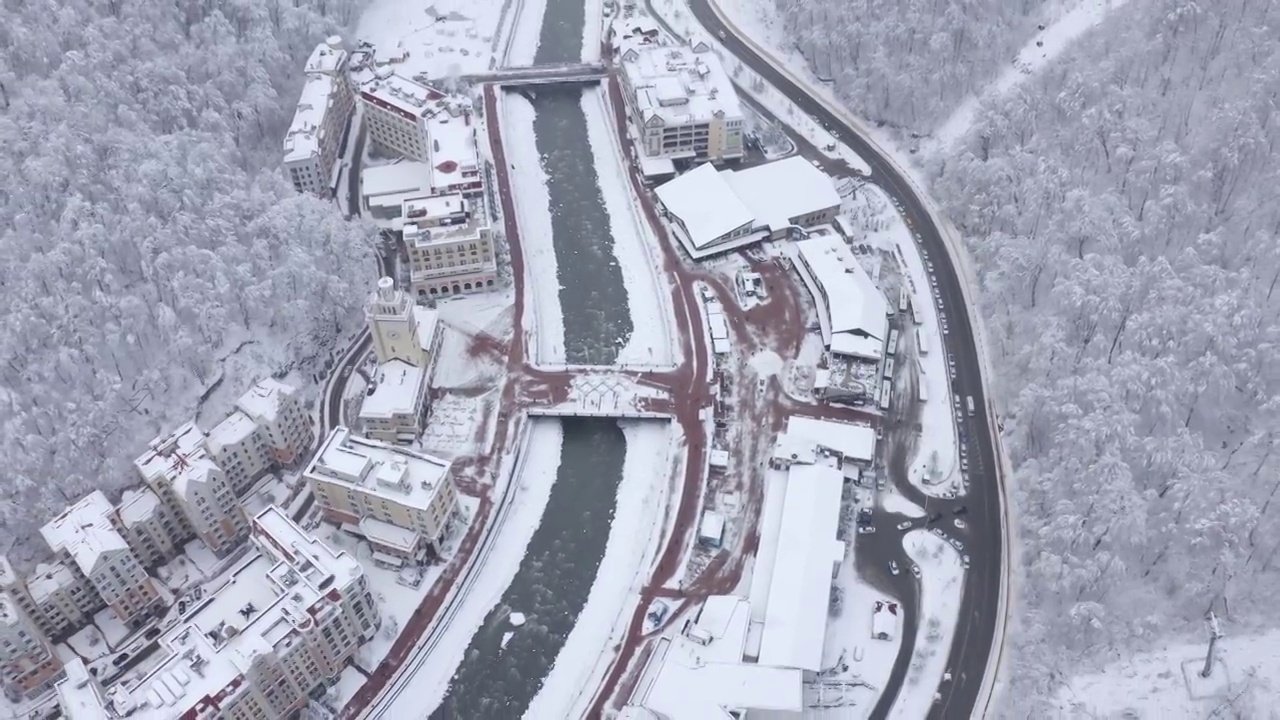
{"left": 724, "top": 155, "right": 844, "bottom": 229}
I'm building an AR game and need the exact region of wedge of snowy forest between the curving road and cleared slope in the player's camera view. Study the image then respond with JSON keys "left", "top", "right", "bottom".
{"left": 774, "top": 0, "right": 1047, "bottom": 133}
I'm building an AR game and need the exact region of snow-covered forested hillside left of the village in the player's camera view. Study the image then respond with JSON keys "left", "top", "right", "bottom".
{"left": 0, "top": 0, "right": 372, "bottom": 547}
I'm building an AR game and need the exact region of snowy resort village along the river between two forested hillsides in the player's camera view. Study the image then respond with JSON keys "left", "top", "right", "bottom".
{"left": 0, "top": 0, "right": 988, "bottom": 720}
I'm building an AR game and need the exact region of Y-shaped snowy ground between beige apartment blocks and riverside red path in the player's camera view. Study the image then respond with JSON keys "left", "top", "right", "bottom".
{"left": 316, "top": 496, "right": 480, "bottom": 681}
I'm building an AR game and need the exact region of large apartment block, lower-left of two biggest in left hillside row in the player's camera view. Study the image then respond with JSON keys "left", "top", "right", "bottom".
{"left": 40, "top": 491, "right": 161, "bottom": 626}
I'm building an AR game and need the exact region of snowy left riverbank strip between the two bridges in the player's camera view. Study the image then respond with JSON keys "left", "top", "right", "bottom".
{"left": 498, "top": 94, "right": 566, "bottom": 365}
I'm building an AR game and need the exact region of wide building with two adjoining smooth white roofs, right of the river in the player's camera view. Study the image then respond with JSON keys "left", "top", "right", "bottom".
{"left": 654, "top": 156, "right": 840, "bottom": 259}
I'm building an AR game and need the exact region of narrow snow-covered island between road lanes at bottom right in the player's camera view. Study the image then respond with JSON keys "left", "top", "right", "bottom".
{"left": 890, "top": 530, "right": 964, "bottom": 720}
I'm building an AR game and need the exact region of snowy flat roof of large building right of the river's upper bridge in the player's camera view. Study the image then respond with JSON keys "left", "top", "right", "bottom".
{"left": 622, "top": 44, "right": 742, "bottom": 126}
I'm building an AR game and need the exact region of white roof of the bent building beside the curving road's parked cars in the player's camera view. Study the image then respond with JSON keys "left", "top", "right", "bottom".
{"left": 795, "top": 234, "right": 888, "bottom": 345}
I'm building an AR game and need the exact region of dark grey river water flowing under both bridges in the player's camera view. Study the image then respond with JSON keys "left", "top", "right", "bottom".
{"left": 433, "top": 0, "right": 632, "bottom": 707}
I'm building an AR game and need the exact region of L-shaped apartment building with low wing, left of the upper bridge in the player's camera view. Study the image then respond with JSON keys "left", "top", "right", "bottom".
{"left": 360, "top": 72, "right": 484, "bottom": 196}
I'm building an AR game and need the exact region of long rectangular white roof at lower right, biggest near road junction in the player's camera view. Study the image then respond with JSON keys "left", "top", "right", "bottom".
{"left": 759, "top": 465, "right": 845, "bottom": 671}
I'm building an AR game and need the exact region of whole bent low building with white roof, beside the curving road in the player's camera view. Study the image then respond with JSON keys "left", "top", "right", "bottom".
{"left": 791, "top": 233, "right": 888, "bottom": 361}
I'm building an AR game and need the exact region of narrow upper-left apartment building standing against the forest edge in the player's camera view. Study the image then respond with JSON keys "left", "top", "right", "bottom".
{"left": 284, "top": 36, "right": 356, "bottom": 196}
